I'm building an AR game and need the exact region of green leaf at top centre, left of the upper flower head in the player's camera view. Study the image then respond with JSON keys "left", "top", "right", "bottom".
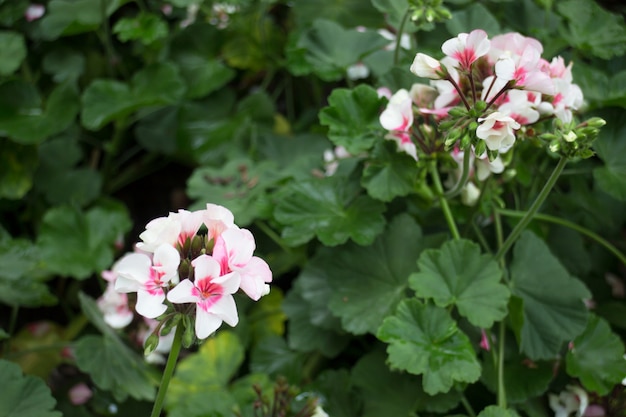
{"left": 297, "top": 19, "right": 389, "bottom": 81}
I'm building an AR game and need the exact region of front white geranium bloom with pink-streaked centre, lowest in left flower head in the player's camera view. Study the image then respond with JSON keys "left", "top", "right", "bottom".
{"left": 167, "top": 255, "right": 240, "bottom": 339}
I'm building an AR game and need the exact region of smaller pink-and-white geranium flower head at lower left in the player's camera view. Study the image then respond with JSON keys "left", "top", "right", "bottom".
{"left": 98, "top": 204, "right": 272, "bottom": 354}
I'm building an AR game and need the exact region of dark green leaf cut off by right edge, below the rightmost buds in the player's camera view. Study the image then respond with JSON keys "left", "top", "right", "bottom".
{"left": 593, "top": 112, "right": 626, "bottom": 201}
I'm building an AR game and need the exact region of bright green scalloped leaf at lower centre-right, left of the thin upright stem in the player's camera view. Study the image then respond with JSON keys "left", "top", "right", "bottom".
{"left": 377, "top": 299, "right": 481, "bottom": 395}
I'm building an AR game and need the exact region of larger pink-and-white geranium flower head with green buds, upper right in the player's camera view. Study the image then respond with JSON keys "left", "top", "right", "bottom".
{"left": 379, "top": 29, "right": 602, "bottom": 203}
